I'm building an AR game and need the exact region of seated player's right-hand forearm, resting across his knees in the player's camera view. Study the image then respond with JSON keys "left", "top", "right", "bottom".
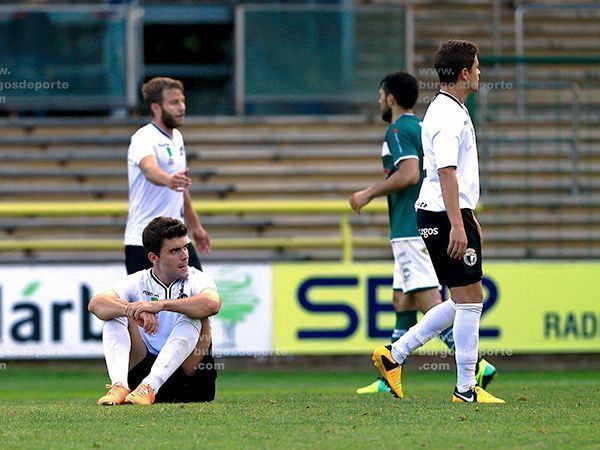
{"left": 126, "top": 288, "right": 221, "bottom": 319}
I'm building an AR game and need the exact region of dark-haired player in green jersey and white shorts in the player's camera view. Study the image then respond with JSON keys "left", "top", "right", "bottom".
{"left": 350, "top": 72, "right": 495, "bottom": 397}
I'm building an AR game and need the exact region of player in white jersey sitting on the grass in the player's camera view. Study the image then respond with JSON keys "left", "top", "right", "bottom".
{"left": 88, "top": 217, "right": 221, "bottom": 405}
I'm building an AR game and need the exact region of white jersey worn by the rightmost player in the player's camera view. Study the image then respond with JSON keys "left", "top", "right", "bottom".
{"left": 415, "top": 91, "right": 479, "bottom": 211}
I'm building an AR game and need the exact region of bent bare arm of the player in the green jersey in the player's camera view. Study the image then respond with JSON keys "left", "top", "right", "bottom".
{"left": 349, "top": 158, "right": 420, "bottom": 214}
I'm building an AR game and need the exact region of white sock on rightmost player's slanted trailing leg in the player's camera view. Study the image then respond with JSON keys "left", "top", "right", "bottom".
{"left": 392, "top": 299, "right": 456, "bottom": 364}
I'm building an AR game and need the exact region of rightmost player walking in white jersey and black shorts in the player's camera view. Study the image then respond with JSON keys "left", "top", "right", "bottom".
{"left": 374, "top": 40, "right": 504, "bottom": 403}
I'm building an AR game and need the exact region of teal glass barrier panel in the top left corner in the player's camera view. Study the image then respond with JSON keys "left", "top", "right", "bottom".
{"left": 0, "top": 5, "right": 143, "bottom": 111}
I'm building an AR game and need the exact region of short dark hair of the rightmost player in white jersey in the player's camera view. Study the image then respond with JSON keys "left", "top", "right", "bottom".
{"left": 433, "top": 39, "right": 479, "bottom": 84}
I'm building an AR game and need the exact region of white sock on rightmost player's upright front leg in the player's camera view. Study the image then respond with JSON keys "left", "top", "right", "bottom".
{"left": 454, "top": 303, "right": 483, "bottom": 392}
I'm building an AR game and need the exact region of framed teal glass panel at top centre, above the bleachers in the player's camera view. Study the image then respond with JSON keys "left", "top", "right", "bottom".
{"left": 235, "top": 5, "right": 414, "bottom": 114}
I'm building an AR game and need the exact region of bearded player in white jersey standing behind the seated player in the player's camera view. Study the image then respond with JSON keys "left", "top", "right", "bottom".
{"left": 125, "top": 77, "right": 211, "bottom": 274}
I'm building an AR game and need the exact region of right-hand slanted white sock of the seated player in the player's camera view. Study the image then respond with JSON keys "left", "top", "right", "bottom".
{"left": 140, "top": 315, "right": 202, "bottom": 393}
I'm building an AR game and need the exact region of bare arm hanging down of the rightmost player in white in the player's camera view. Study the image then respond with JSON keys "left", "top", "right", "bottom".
{"left": 438, "top": 166, "right": 467, "bottom": 259}
